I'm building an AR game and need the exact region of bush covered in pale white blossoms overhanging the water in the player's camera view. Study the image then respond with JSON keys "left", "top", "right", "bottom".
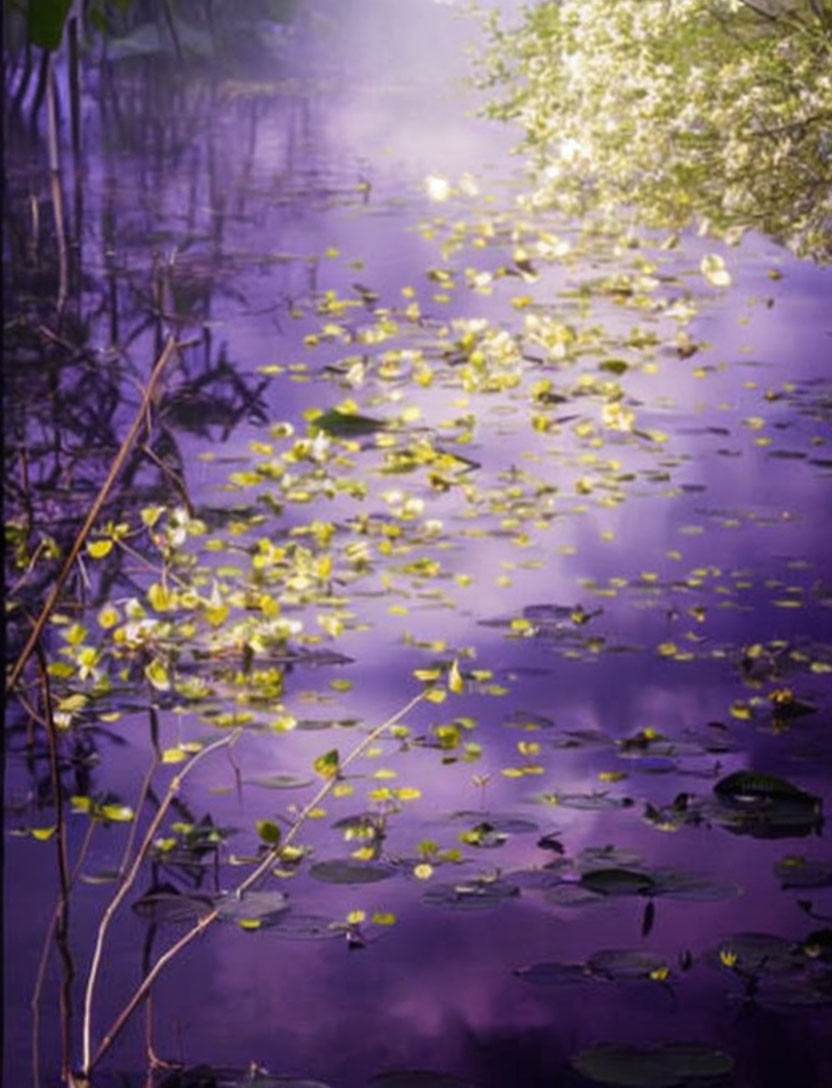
{"left": 484, "top": 0, "right": 832, "bottom": 260}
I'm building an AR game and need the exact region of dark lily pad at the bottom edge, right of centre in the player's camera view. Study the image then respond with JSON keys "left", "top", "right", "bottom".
{"left": 572, "top": 1042, "right": 734, "bottom": 1088}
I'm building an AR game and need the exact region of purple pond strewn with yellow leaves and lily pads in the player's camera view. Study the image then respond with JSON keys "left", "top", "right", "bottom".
{"left": 3, "top": 0, "right": 832, "bottom": 1088}
